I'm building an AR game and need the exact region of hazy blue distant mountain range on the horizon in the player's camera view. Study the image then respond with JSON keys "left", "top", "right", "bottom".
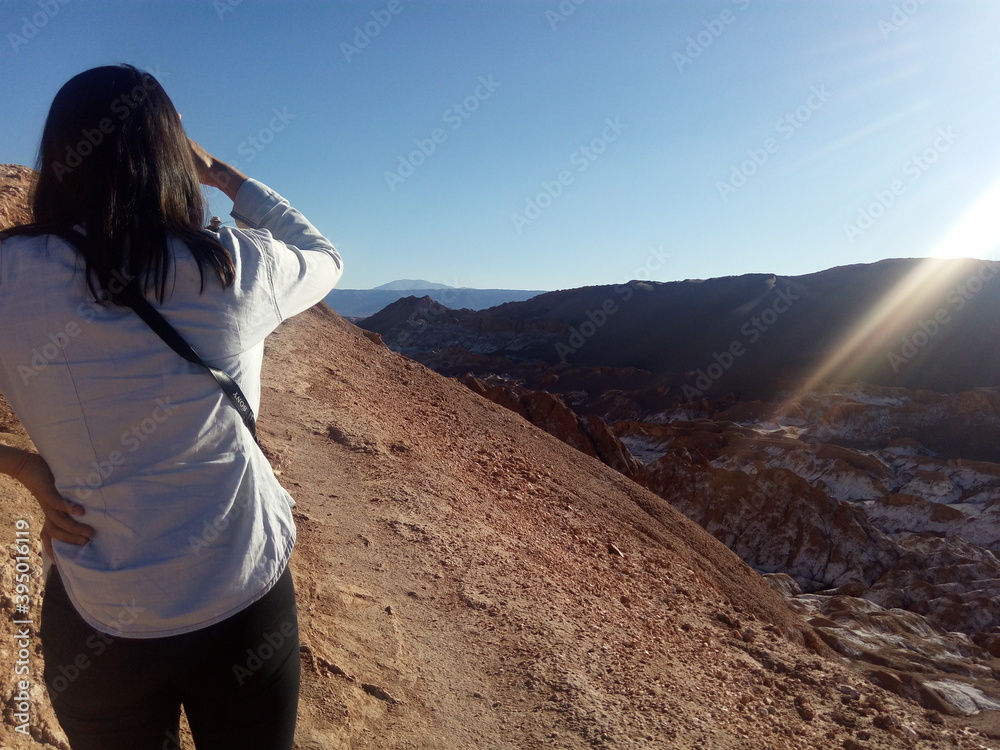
{"left": 326, "top": 279, "right": 544, "bottom": 319}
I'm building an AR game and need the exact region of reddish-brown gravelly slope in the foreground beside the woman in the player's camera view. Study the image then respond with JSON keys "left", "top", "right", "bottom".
{"left": 0, "top": 166, "right": 1000, "bottom": 750}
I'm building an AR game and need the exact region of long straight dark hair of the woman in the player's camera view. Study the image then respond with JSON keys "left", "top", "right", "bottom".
{"left": 4, "top": 65, "right": 235, "bottom": 302}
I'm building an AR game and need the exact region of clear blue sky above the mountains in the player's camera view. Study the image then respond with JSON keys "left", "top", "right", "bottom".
{"left": 0, "top": 0, "right": 1000, "bottom": 289}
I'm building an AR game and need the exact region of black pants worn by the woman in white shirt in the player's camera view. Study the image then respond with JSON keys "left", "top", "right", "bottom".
{"left": 40, "top": 568, "right": 299, "bottom": 750}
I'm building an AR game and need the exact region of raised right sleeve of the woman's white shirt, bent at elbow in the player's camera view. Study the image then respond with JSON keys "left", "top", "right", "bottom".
{"left": 232, "top": 180, "right": 344, "bottom": 320}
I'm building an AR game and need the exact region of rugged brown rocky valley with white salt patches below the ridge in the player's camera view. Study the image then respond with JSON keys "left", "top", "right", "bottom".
{"left": 468, "top": 386, "right": 1000, "bottom": 740}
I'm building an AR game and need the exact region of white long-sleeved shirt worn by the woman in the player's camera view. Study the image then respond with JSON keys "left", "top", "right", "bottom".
{"left": 0, "top": 180, "right": 342, "bottom": 638}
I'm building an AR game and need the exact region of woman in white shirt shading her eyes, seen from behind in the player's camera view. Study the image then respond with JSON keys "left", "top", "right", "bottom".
{"left": 0, "top": 65, "right": 342, "bottom": 750}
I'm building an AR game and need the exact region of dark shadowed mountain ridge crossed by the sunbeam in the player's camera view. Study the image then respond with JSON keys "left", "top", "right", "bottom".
{"left": 362, "top": 259, "right": 1000, "bottom": 406}
